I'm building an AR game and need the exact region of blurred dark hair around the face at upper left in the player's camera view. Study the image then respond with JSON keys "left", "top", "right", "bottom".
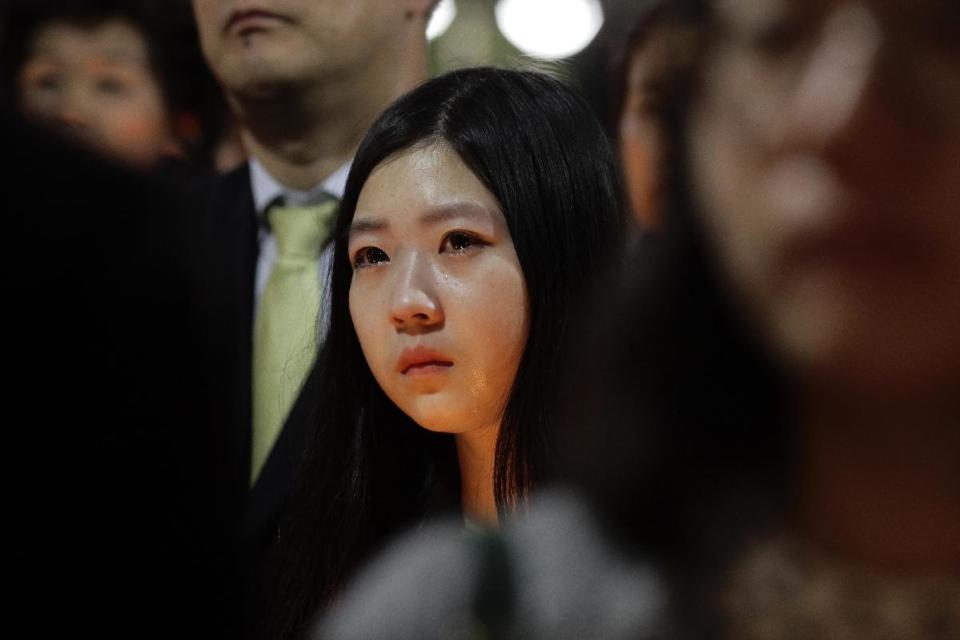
{"left": 0, "top": 0, "right": 228, "bottom": 167}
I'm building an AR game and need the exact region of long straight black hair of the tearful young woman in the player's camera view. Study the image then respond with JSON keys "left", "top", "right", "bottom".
{"left": 274, "top": 68, "right": 625, "bottom": 637}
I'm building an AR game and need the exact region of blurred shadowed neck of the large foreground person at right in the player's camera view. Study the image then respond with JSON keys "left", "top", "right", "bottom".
{"left": 798, "top": 396, "right": 960, "bottom": 573}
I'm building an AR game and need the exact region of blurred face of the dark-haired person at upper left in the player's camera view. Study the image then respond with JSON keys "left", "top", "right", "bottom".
{"left": 19, "top": 20, "right": 174, "bottom": 166}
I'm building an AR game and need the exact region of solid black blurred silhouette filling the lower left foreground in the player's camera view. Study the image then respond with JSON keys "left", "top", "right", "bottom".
{"left": 0, "top": 102, "right": 223, "bottom": 639}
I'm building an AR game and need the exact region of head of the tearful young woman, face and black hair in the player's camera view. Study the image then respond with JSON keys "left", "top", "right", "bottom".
{"left": 328, "top": 69, "right": 621, "bottom": 499}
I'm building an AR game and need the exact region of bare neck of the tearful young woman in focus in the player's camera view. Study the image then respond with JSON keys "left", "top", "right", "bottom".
{"left": 453, "top": 424, "right": 500, "bottom": 526}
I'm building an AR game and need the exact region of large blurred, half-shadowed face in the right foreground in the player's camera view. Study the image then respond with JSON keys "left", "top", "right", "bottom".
{"left": 690, "top": 0, "right": 960, "bottom": 394}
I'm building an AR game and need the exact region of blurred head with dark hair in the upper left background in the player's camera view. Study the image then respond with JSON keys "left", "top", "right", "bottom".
{"left": 4, "top": 0, "right": 226, "bottom": 172}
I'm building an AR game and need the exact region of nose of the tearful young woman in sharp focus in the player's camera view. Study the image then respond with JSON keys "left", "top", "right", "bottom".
{"left": 390, "top": 254, "right": 444, "bottom": 333}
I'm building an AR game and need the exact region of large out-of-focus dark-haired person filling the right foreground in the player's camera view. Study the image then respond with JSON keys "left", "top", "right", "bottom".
{"left": 320, "top": 0, "right": 960, "bottom": 640}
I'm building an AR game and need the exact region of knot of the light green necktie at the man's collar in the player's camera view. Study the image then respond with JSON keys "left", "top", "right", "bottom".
{"left": 267, "top": 199, "right": 338, "bottom": 261}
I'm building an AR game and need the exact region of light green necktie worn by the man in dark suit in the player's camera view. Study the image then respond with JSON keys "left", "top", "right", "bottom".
{"left": 250, "top": 199, "right": 339, "bottom": 485}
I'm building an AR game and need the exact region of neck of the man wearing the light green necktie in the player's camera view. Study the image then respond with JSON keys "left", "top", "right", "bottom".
{"left": 230, "top": 45, "right": 427, "bottom": 190}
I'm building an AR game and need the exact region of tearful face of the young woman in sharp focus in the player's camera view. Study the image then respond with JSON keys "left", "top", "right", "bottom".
{"left": 348, "top": 143, "right": 529, "bottom": 433}
